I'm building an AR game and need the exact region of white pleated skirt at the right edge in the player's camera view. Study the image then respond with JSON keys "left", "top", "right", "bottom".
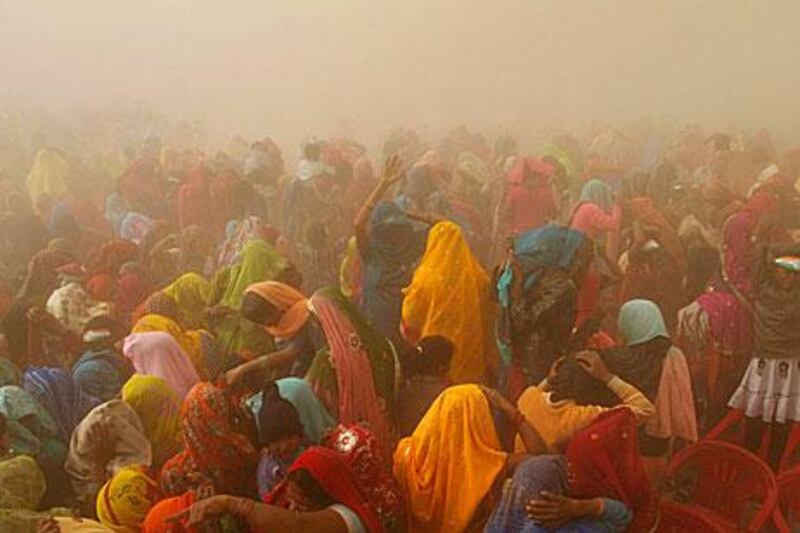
{"left": 728, "top": 359, "right": 800, "bottom": 424}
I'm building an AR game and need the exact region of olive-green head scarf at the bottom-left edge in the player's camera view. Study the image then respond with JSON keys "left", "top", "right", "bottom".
{"left": 0, "top": 455, "right": 47, "bottom": 511}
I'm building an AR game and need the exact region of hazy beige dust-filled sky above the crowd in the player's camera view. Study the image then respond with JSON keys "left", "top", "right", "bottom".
{"left": 0, "top": 0, "right": 800, "bottom": 149}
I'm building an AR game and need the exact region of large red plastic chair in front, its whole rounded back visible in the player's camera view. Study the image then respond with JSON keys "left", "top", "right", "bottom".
{"left": 667, "top": 440, "right": 778, "bottom": 531}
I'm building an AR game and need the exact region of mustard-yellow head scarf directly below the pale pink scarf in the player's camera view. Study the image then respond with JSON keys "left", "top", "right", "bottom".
{"left": 122, "top": 374, "right": 181, "bottom": 466}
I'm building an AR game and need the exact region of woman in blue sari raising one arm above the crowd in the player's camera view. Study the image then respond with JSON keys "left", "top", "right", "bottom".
{"left": 355, "top": 158, "right": 425, "bottom": 345}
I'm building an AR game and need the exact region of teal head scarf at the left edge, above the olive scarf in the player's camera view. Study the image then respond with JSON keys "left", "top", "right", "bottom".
{"left": 0, "top": 385, "right": 63, "bottom": 458}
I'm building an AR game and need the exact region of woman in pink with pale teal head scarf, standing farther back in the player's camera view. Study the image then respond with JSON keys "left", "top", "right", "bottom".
{"left": 569, "top": 179, "right": 622, "bottom": 325}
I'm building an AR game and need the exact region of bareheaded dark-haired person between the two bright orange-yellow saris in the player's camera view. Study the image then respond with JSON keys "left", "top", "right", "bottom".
{"left": 397, "top": 335, "right": 453, "bottom": 437}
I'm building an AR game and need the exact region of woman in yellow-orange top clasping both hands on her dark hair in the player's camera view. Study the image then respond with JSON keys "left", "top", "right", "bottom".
{"left": 515, "top": 351, "right": 655, "bottom": 455}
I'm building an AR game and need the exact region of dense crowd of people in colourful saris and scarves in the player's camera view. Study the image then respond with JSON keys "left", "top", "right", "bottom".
{"left": 0, "top": 118, "right": 800, "bottom": 533}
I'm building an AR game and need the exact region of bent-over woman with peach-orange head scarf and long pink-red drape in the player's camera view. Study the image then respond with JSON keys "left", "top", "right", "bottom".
{"left": 231, "top": 281, "right": 395, "bottom": 450}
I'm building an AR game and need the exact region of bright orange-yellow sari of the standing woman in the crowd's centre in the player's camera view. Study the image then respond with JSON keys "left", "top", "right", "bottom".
{"left": 403, "top": 222, "right": 497, "bottom": 383}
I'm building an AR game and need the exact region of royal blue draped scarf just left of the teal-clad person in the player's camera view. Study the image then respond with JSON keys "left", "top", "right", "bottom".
{"left": 22, "top": 367, "right": 100, "bottom": 442}
